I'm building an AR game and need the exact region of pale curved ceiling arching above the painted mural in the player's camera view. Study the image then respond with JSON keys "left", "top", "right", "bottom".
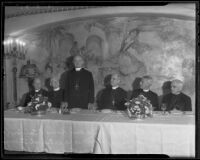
{"left": 5, "top": 3, "right": 195, "bottom": 37}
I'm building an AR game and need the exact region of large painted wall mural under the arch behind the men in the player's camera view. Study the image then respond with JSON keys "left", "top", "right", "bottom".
{"left": 18, "top": 16, "right": 195, "bottom": 107}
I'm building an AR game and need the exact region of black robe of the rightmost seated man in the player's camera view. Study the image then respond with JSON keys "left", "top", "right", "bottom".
{"left": 162, "top": 93, "right": 192, "bottom": 111}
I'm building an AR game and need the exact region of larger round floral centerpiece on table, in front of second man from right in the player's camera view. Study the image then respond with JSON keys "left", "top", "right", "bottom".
{"left": 125, "top": 95, "right": 153, "bottom": 119}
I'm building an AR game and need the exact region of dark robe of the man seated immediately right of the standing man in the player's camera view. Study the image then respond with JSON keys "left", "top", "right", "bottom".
{"left": 97, "top": 87, "right": 127, "bottom": 110}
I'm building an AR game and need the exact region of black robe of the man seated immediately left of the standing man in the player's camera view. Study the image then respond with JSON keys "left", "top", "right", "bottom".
{"left": 48, "top": 89, "right": 64, "bottom": 108}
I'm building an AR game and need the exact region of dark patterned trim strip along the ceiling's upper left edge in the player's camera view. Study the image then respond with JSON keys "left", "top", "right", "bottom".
{"left": 5, "top": 6, "right": 104, "bottom": 19}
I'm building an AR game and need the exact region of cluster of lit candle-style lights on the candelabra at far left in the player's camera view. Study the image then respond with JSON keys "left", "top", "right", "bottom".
{"left": 4, "top": 38, "right": 27, "bottom": 60}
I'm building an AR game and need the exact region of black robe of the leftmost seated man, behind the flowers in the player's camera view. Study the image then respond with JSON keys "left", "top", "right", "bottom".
{"left": 23, "top": 88, "right": 48, "bottom": 107}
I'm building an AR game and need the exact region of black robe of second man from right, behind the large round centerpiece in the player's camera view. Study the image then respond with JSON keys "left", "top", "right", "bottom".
{"left": 131, "top": 89, "right": 160, "bottom": 110}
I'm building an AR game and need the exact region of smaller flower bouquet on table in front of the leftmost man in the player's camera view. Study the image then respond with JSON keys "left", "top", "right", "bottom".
{"left": 25, "top": 94, "right": 52, "bottom": 115}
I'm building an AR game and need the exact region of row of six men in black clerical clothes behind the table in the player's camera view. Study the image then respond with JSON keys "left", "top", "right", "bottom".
{"left": 24, "top": 55, "right": 192, "bottom": 111}
